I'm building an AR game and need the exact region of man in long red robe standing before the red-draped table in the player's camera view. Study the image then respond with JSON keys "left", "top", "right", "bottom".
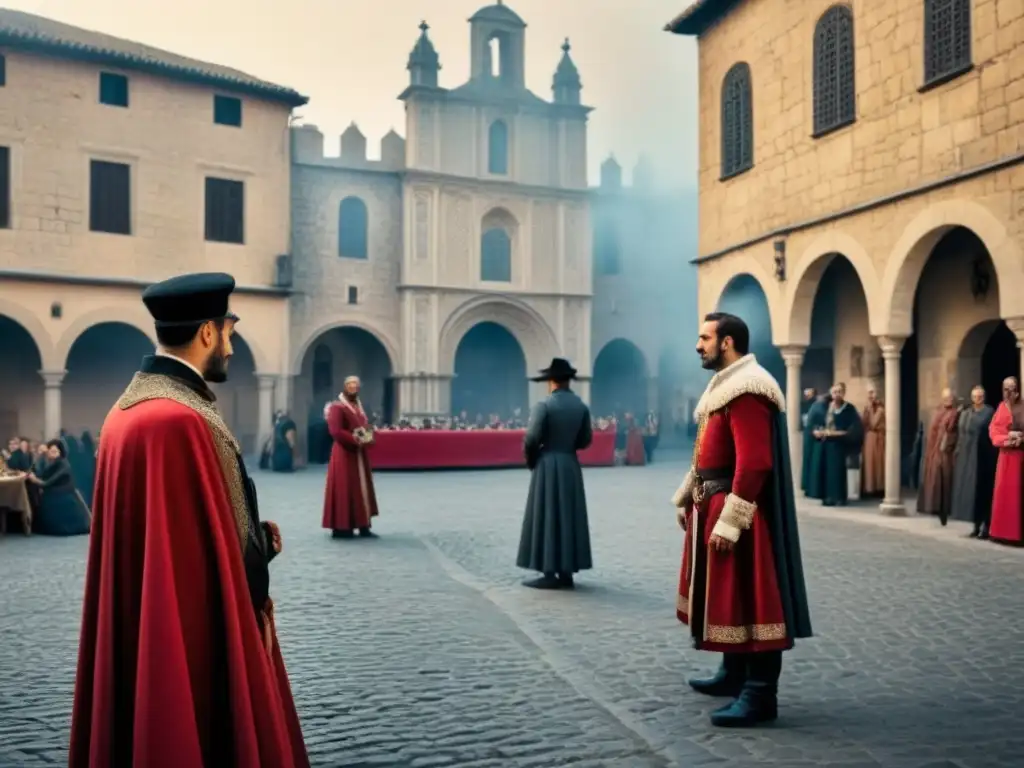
{"left": 323, "top": 376, "right": 377, "bottom": 539}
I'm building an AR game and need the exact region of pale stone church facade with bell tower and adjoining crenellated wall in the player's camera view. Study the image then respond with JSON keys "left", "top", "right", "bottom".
{"left": 291, "top": 3, "right": 591, "bottom": 430}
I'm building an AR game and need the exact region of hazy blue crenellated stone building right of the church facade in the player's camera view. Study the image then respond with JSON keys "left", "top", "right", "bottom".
{"left": 591, "top": 149, "right": 707, "bottom": 425}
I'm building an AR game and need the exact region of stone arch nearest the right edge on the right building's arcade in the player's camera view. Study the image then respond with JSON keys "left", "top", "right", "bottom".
{"left": 879, "top": 199, "right": 1024, "bottom": 337}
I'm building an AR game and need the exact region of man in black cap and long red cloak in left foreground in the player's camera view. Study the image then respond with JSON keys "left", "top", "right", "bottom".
{"left": 70, "top": 273, "right": 309, "bottom": 768}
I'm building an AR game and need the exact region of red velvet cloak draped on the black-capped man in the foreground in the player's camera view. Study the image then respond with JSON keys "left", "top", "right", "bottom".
{"left": 70, "top": 399, "right": 309, "bottom": 768}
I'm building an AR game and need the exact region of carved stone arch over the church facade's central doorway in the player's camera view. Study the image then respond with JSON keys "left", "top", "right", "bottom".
{"left": 438, "top": 296, "right": 561, "bottom": 375}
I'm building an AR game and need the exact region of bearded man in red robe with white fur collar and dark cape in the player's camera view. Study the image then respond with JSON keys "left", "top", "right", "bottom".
{"left": 673, "top": 312, "right": 811, "bottom": 727}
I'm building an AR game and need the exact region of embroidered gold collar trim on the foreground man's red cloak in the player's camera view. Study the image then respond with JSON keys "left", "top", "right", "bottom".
{"left": 117, "top": 373, "right": 249, "bottom": 549}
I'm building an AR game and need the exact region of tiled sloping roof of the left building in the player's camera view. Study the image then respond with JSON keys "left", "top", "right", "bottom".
{"left": 0, "top": 8, "right": 309, "bottom": 106}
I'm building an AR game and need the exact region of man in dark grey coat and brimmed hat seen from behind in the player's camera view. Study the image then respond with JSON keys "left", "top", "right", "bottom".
{"left": 516, "top": 357, "right": 594, "bottom": 590}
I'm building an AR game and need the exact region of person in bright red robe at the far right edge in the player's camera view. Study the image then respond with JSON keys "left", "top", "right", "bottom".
{"left": 988, "top": 376, "right": 1024, "bottom": 545}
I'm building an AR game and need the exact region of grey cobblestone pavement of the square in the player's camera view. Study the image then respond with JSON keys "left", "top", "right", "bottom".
{"left": 0, "top": 459, "right": 1024, "bottom": 768}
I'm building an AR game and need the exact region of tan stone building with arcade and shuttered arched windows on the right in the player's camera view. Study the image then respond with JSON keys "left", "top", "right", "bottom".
{"left": 668, "top": 0, "right": 1024, "bottom": 514}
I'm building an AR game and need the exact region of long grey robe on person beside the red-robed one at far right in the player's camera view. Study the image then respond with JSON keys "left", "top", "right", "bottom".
{"left": 950, "top": 406, "right": 996, "bottom": 526}
